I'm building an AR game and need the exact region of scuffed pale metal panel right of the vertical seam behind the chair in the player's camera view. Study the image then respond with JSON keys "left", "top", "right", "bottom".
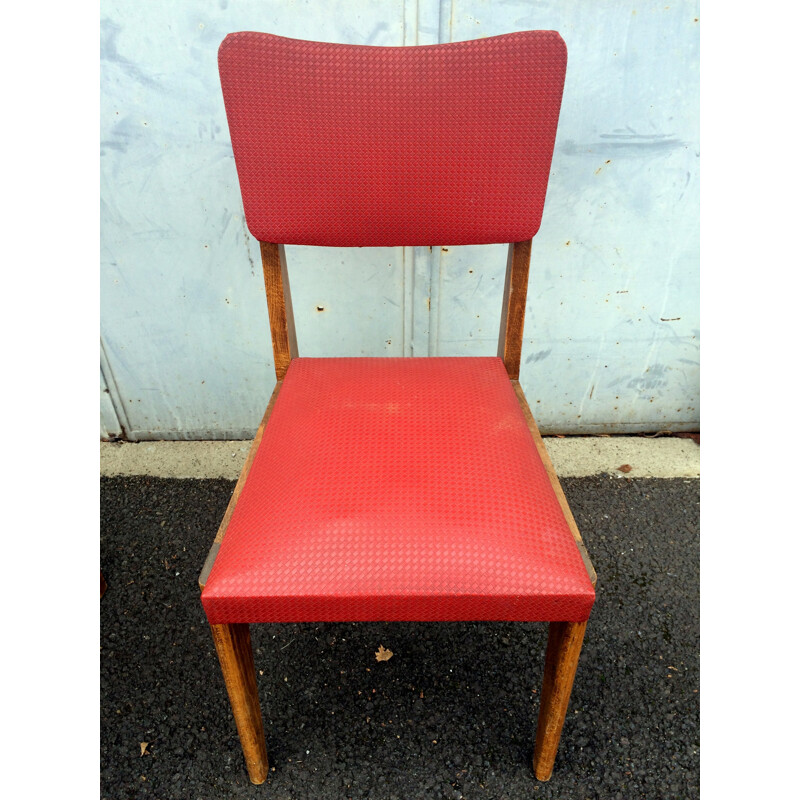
{"left": 444, "top": 0, "right": 700, "bottom": 433}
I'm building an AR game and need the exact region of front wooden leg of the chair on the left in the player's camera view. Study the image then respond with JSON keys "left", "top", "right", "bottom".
{"left": 211, "top": 623, "right": 269, "bottom": 783}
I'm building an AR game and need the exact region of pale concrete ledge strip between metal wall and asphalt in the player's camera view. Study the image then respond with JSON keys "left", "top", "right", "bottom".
{"left": 100, "top": 436, "right": 700, "bottom": 480}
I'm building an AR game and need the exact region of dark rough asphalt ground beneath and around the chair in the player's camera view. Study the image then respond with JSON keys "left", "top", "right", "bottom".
{"left": 100, "top": 476, "right": 700, "bottom": 800}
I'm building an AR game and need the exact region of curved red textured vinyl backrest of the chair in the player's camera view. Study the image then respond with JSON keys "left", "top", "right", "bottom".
{"left": 219, "top": 31, "right": 567, "bottom": 246}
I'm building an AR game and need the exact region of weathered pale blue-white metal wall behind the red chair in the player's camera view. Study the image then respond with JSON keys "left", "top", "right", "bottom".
{"left": 101, "top": 0, "right": 699, "bottom": 439}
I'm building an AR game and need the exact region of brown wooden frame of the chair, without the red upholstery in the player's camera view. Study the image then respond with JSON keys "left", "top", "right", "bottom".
{"left": 199, "top": 239, "right": 597, "bottom": 784}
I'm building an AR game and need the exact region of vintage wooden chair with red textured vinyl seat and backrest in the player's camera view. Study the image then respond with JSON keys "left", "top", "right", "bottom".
{"left": 200, "top": 31, "right": 596, "bottom": 783}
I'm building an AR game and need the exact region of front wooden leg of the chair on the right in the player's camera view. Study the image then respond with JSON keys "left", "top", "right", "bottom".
{"left": 533, "top": 622, "right": 586, "bottom": 781}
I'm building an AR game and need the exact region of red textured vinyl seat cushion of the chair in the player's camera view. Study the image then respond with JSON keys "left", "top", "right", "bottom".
{"left": 202, "top": 358, "right": 594, "bottom": 624}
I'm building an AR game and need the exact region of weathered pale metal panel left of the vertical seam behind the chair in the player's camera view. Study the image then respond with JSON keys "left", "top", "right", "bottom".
{"left": 101, "top": 0, "right": 416, "bottom": 439}
